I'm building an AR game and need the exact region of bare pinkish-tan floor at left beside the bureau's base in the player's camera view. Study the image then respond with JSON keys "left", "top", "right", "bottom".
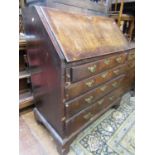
{"left": 19, "top": 110, "right": 74, "bottom": 155}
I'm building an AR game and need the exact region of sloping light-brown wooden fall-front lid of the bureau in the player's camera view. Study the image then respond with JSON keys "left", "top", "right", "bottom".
{"left": 38, "top": 7, "right": 128, "bottom": 62}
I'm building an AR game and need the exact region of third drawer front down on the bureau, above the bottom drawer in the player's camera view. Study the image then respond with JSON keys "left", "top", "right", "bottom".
{"left": 65, "top": 75, "right": 125, "bottom": 118}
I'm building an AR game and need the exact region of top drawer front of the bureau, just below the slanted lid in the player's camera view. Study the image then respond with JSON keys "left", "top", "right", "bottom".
{"left": 71, "top": 53, "right": 126, "bottom": 82}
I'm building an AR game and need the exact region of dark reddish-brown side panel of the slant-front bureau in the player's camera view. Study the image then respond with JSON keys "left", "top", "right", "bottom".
{"left": 24, "top": 7, "right": 64, "bottom": 137}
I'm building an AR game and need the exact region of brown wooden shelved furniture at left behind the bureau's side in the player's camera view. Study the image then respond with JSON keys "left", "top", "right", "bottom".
{"left": 19, "top": 35, "right": 33, "bottom": 110}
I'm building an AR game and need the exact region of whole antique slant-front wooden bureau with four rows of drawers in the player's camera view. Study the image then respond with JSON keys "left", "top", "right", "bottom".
{"left": 23, "top": 6, "right": 134, "bottom": 154}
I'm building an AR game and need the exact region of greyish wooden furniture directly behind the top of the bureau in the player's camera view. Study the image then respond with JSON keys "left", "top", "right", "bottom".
{"left": 26, "top": 0, "right": 106, "bottom": 15}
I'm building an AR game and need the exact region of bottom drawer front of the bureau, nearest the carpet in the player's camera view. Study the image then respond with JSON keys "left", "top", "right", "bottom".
{"left": 66, "top": 87, "right": 124, "bottom": 135}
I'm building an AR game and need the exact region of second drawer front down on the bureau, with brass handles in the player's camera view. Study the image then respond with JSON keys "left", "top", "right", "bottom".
{"left": 65, "top": 64, "right": 127, "bottom": 101}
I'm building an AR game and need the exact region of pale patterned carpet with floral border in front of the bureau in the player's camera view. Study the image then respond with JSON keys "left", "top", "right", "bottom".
{"left": 69, "top": 93, "right": 135, "bottom": 155}
